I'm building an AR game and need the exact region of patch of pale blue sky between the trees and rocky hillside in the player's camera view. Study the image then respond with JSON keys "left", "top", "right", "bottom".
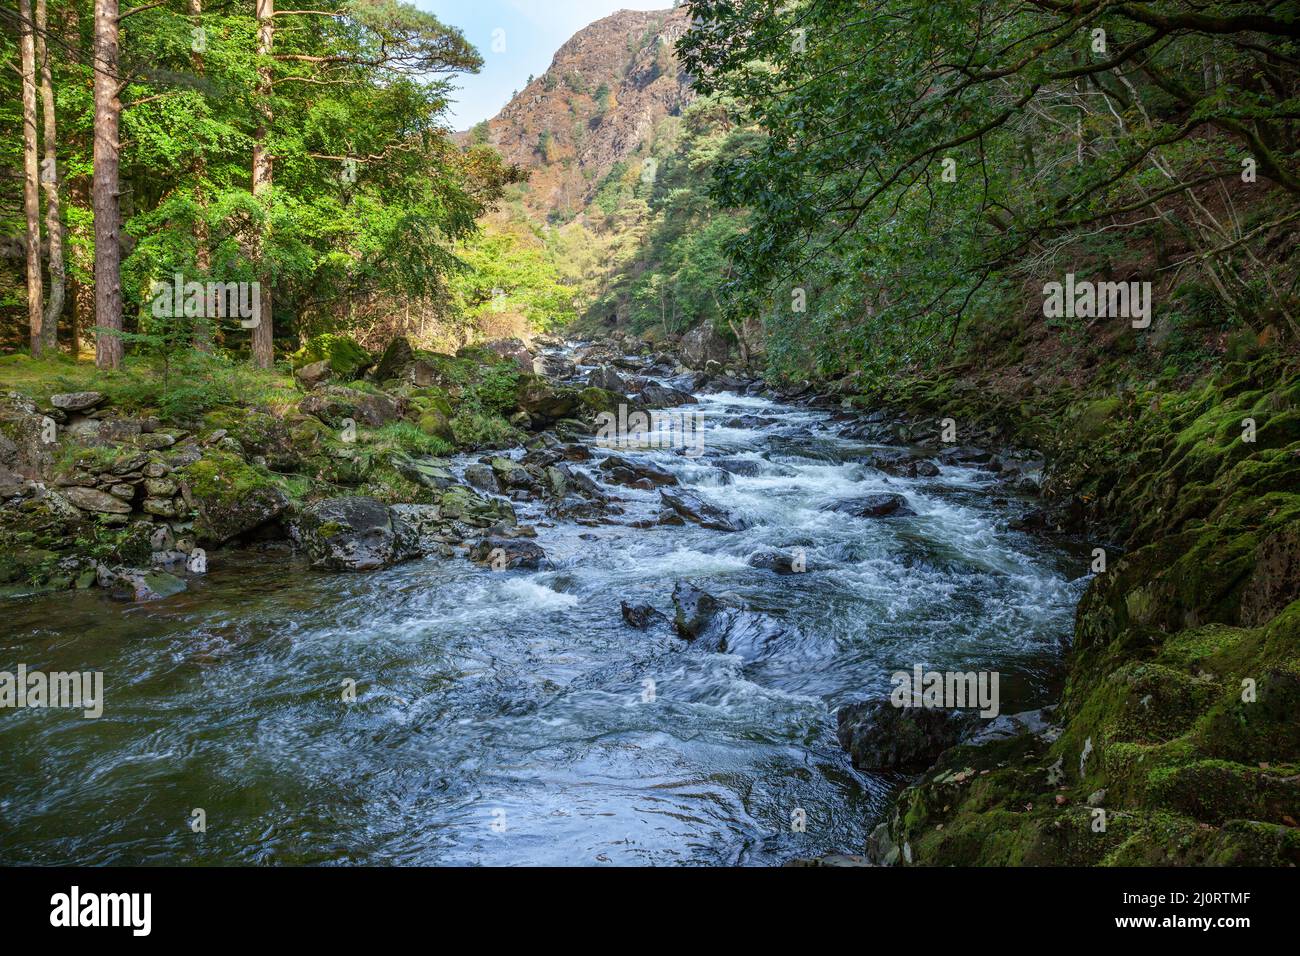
{"left": 426, "top": 0, "right": 672, "bottom": 130}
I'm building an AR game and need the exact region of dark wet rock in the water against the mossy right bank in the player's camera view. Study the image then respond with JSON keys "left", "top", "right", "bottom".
{"left": 836, "top": 700, "right": 972, "bottom": 770}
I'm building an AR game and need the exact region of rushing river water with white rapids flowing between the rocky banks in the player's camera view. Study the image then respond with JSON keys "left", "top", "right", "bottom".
{"left": 0, "top": 366, "right": 1082, "bottom": 865}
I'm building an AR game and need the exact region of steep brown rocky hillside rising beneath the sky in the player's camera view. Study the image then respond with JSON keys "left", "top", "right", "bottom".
{"left": 468, "top": 9, "right": 692, "bottom": 219}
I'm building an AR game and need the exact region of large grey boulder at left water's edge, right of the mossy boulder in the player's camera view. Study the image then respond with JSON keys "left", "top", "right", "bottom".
{"left": 294, "top": 497, "right": 419, "bottom": 571}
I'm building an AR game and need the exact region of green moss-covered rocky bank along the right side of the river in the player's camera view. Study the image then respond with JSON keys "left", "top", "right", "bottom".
{"left": 854, "top": 356, "right": 1300, "bottom": 865}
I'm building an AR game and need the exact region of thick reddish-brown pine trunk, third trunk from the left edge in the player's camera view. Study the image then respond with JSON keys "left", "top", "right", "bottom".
{"left": 91, "top": 0, "right": 122, "bottom": 368}
